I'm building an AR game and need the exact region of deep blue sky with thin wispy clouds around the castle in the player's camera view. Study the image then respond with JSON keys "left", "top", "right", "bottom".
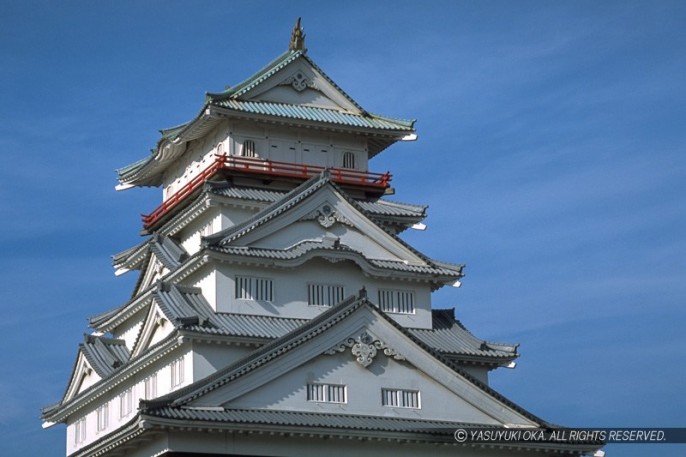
{"left": 0, "top": 0, "right": 686, "bottom": 457}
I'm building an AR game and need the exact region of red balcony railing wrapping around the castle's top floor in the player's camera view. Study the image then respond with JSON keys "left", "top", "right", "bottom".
{"left": 142, "top": 154, "right": 392, "bottom": 228}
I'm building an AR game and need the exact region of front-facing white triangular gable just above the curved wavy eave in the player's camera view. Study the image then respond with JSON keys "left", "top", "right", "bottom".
{"left": 205, "top": 175, "right": 428, "bottom": 265}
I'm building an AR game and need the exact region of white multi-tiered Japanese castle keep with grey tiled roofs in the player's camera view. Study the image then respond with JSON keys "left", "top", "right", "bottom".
{"left": 42, "top": 21, "right": 600, "bottom": 457}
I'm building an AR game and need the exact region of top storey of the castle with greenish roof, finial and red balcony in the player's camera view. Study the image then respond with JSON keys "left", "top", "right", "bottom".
{"left": 117, "top": 20, "right": 416, "bottom": 230}
